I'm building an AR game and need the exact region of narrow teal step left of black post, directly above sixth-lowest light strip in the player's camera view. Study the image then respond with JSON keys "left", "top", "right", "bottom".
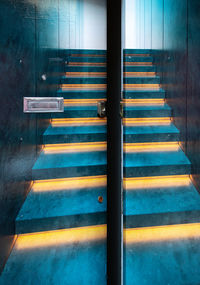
{"left": 61, "top": 76, "right": 107, "bottom": 84}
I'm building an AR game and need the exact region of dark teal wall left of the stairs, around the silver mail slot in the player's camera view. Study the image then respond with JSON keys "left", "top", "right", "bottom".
{"left": 0, "top": 0, "right": 59, "bottom": 269}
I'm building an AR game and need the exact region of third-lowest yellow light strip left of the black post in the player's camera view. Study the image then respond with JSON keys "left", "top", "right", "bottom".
{"left": 43, "top": 142, "right": 107, "bottom": 154}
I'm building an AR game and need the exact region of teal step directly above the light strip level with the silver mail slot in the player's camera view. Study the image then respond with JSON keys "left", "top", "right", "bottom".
{"left": 57, "top": 89, "right": 107, "bottom": 99}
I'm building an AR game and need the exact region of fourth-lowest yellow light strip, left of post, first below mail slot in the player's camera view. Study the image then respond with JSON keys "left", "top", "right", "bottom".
{"left": 51, "top": 118, "right": 107, "bottom": 127}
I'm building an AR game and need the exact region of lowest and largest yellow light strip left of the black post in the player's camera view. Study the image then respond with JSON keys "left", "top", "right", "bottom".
{"left": 15, "top": 225, "right": 107, "bottom": 250}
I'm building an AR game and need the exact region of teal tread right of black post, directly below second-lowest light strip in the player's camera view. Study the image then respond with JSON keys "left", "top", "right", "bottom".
{"left": 124, "top": 183, "right": 200, "bottom": 215}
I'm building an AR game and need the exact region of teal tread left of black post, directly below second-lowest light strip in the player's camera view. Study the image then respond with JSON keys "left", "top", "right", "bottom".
{"left": 17, "top": 187, "right": 106, "bottom": 222}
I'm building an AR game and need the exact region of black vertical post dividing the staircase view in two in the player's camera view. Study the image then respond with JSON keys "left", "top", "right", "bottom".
{"left": 107, "top": 0, "right": 122, "bottom": 285}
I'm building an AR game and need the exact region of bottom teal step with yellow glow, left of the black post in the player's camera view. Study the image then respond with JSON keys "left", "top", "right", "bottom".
{"left": 0, "top": 235, "right": 107, "bottom": 285}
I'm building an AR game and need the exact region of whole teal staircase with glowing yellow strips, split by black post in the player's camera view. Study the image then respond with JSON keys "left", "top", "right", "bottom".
{"left": 0, "top": 50, "right": 200, "bottom": 285}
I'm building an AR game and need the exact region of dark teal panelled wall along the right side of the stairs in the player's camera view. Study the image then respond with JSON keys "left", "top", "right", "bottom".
{"left": 152, "top": 0, "right": 200, "bottom": 189}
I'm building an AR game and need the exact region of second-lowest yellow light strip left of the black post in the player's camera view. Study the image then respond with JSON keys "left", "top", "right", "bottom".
{"left": 32, "top": 175, "right": 107, "bottom": 192}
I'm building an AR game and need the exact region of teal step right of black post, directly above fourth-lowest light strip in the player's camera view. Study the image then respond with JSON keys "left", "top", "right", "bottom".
{"left": 124, "top": 104, "right": 171, "bottom": 118}
